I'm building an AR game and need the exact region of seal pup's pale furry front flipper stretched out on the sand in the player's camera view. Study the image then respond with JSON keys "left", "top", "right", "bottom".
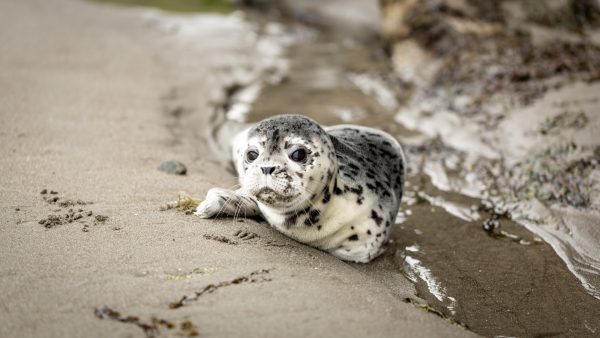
{"left": 195, "top": 188, "right": 260, "bottom": 218}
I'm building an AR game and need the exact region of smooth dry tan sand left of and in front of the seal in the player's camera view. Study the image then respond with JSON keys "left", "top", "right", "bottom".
{"left": 0, "top": 0, "right": 470, "bottom": 337}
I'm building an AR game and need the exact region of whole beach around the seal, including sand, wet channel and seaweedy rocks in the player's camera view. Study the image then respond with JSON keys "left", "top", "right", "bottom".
{"left": 0, "top": 0, "right": 600, "bottom": 337}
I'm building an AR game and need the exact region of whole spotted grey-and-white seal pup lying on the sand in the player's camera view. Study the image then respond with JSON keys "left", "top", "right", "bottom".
{"left": 196, "top": 115, "right": 405, "bottom": 263}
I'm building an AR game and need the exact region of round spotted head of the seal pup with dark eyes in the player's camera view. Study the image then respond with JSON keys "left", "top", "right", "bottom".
{"left": 236, "top": 115, "right": 337, "bottom": 212}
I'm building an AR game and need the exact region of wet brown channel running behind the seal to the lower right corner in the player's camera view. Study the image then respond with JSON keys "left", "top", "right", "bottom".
{"left": 230, "top": 11, "right": 600, "bottom": 336}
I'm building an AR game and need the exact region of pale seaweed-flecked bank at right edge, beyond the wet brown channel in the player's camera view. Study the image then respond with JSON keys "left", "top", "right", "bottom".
{"left": 396, "top": 83, "right": 600, "bottom": 299}
